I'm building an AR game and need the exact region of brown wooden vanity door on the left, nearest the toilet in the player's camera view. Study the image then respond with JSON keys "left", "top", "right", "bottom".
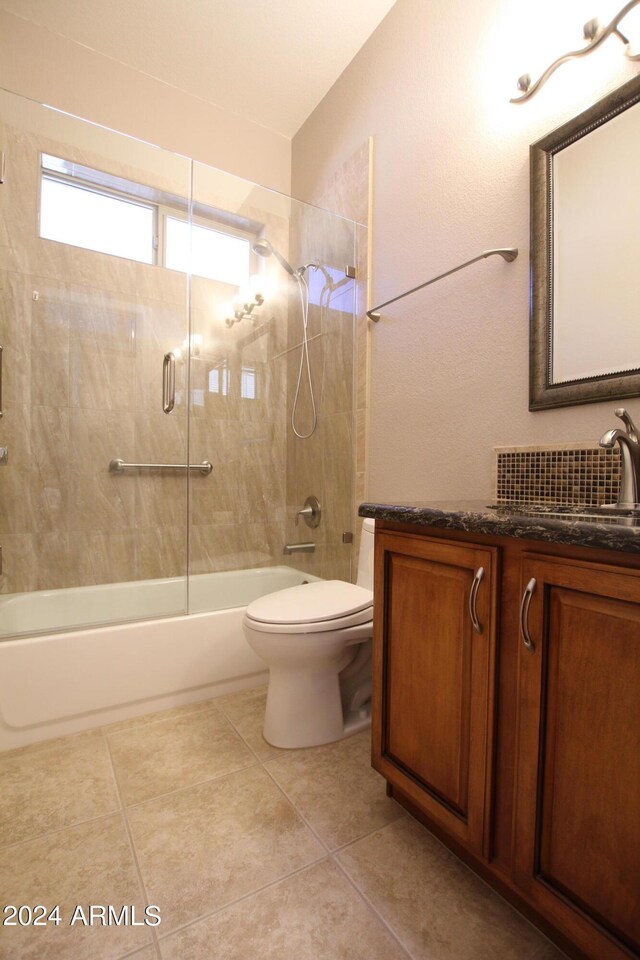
{"left": 373, "top": 533, "right": 497, "bottom": 855}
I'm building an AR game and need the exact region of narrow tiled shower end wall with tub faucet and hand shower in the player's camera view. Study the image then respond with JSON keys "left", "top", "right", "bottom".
{"left": 287, "top": 141, "right": 370, "bottom": 579}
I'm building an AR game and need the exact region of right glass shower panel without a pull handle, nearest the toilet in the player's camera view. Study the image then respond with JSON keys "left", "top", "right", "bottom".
{"left": 189, "top": 157, "right": 355, "bottom": 612}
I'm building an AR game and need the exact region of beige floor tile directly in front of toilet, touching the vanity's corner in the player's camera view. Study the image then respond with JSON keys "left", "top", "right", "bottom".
{"left": 266, "top": 730, "right": 402, "bottom": 850}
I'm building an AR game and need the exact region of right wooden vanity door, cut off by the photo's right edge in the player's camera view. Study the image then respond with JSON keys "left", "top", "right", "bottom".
{"left": 514, "top": 555, "right": 640, "bottom": 960}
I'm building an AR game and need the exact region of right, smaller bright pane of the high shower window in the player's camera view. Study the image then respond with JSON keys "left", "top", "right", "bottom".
{"left": 165, "top": 217, "right": 249, "bottom": 287}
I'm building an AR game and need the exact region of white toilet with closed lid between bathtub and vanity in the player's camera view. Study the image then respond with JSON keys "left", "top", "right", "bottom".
{"left": 243, "top": 520, "right": 375, "bottom": 747}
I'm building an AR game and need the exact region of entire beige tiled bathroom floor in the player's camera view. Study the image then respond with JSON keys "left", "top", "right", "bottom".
{"left": 0, "top": 690, "right": 562, "bottom": 960}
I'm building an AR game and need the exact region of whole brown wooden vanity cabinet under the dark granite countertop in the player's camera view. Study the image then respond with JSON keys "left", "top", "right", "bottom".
{"left": 372, "top": 523, "right": 640, "bottom": 960}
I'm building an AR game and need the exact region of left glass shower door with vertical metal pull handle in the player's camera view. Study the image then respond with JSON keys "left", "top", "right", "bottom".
{"left": 0, "top": 86, "right": 191, "bottom": 635}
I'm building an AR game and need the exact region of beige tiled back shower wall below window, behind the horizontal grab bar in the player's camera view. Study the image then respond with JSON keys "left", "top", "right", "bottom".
{"left": 0, "top": 120, "right": 286, "bottom": 593}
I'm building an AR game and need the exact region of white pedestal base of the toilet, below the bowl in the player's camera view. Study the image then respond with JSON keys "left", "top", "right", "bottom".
{"left": 263, "top": 667, "right": 371, "bottom": 750}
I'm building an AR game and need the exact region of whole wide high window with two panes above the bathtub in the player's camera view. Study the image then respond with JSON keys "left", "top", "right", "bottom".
{"left": 40, "top": 154, "right": 252, "bottom": 287}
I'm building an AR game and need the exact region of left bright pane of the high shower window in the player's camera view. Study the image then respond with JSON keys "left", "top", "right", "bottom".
{"left": 40, "top": 177, "right": 153, "bottom": 263}
